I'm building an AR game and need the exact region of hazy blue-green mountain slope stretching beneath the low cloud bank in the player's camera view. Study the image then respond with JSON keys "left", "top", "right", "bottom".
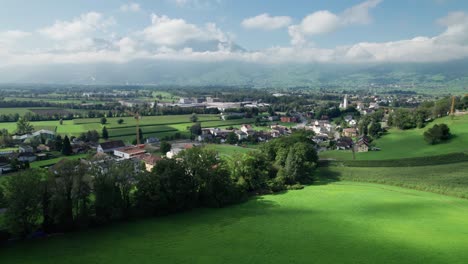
{"left": 0, "top": 60, "right": 468, "bottom": 91}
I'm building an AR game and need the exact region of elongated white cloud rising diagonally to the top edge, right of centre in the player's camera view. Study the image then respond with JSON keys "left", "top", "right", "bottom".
{"left": 288, "top": 0, "right": 381, "bottom": 45}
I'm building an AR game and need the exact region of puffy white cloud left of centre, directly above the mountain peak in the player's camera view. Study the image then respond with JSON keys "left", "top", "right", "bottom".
{"left": 142, "top": 14, "right": 227, "bottom": 46}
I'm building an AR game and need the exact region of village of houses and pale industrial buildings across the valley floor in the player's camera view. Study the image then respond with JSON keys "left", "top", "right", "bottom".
{"left": 0, "top": 91, "right": 391, "bottom": 173}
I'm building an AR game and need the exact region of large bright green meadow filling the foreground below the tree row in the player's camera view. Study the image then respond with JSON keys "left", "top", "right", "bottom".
{"left": 0, "top": 182, "right": 468, "bottom": 264}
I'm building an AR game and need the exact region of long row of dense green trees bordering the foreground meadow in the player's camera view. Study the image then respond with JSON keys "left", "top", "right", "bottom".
{"left": 0, "top": 133, "right": 317, "bottom": 237}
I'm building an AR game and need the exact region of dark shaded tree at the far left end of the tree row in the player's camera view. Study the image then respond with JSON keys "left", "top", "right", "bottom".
{"left": 5, "top": 170, "right": 43, "bottom": 237}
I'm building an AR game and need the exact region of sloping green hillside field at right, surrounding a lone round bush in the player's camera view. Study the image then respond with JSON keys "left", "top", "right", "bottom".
{"left": 320, "top": 115, "right": 468, "bottom": 160}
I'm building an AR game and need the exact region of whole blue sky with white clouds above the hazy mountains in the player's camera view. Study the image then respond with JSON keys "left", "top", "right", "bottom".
{"left": 0, "top": 0, "right": 468, "bottom": 66}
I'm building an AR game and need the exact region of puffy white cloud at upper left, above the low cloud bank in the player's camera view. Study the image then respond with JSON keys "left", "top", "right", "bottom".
{"left": 38, "top": 12, "right": 115, "bottom": 40}
